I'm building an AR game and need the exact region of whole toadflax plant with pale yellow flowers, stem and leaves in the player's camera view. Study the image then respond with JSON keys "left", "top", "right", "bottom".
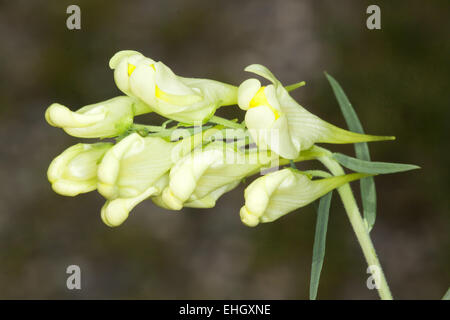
{"left": 45, "top": 50, "right": 426, "bottom": 299}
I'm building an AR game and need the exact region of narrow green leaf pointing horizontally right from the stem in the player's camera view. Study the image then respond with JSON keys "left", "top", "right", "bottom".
{"left": 333, "top": 153, "right": 420, "bottom": 174}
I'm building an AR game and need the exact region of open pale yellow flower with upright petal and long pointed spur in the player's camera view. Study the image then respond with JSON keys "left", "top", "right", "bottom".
{"left": 238, "top": 64, "right": 392, "bottom": 159}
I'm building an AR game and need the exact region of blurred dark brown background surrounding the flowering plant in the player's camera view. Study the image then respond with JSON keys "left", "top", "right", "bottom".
{"left": 0, "top": 0, "right": 450, "bottom": 299}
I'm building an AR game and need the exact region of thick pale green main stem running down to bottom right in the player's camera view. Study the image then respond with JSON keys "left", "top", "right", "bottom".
{"left": 318, "top": 148, "right": 392, "bottom": 300}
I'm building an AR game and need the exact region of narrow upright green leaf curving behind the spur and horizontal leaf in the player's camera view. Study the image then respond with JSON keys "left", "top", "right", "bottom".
{"left": 325, "top": 72, "right": 377, "bottom": 232}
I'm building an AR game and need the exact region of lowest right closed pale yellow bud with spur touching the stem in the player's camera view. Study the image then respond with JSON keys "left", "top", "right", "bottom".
{"left": 240, "top": 168, "right": 368, "bottom": 227}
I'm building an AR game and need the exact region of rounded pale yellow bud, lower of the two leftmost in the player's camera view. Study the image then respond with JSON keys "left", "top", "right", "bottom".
{"left": 47, "top": 143, "right": 112, "bottom": 196}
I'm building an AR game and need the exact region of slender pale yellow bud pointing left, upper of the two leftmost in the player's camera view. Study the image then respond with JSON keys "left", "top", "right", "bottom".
{"left": 45, "top": 96, "right": 149, "bottom": 138}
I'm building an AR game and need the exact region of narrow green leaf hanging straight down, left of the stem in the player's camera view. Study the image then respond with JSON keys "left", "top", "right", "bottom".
{"left": 309, "top": 192, "right": 333, "bottom": 300}
